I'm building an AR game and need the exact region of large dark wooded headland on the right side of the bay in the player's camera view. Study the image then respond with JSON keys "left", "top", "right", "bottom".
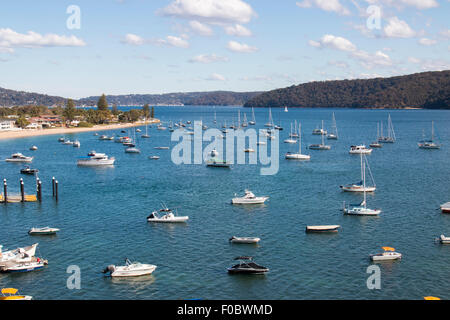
{"left": 244, "top": 70, "right": 450, "bottom": 109}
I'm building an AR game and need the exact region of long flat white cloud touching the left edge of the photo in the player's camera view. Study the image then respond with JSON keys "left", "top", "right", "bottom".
{"left": 0, "top": 28, "right": 86, "bottom": 53}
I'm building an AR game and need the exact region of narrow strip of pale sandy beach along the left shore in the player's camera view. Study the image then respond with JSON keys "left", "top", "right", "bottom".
{"left": 0, "top": 119, "right": 160, "bottom": 140}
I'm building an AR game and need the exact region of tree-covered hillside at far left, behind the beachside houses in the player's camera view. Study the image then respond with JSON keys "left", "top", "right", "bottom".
{"left": 0, "top": 88, "right": 66, "bottom": 107}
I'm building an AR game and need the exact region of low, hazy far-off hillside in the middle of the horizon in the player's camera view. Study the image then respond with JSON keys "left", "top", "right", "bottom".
{"left": 78, "top": 91, "right": 261, "bottom": 106}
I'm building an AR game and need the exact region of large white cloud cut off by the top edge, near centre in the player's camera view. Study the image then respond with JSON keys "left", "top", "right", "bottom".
{"left": 160, "top": 0, "right": 256, "bottom": 23}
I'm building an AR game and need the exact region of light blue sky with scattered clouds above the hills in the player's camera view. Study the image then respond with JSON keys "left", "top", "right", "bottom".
{"left": 0, "top": 0, "right": 450, "bottom": 98}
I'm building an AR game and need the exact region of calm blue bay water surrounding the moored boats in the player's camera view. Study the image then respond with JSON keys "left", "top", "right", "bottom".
{"left": 0, "top": 107, "right": 450, "bottom": 299}
